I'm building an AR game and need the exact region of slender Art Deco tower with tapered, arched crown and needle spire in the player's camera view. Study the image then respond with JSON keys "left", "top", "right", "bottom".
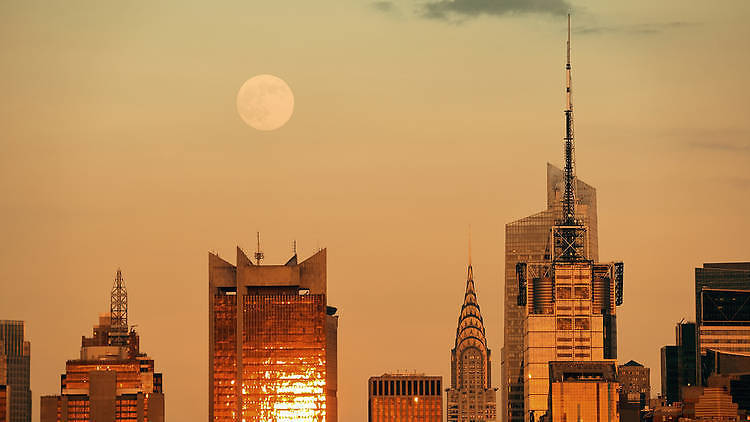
{"left": 446, "top": 261, "right": 497, "bottom": 422}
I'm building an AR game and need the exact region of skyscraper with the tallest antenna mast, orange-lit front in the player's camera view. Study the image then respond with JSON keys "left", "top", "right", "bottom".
{"left": 516, "top": 16, "right": 623, "bottom": 421}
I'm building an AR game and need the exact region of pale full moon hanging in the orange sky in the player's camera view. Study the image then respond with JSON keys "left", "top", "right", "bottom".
{"left": 237, "top": 75, "right": 294, "bottom": 131}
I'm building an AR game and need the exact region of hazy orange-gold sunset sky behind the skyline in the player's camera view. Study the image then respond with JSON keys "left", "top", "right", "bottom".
{"left": 0, "top": 0, "right": 750, "bottom": 422}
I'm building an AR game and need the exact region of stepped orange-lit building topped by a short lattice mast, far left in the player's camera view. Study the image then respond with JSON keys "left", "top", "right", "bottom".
{"left": 40, "top": 270, "right": 164, "bottom": 422}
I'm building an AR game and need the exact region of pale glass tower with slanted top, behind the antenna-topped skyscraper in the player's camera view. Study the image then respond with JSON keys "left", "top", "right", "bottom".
{"left": 500, "top": 163, "right": 604, "bottom": 422}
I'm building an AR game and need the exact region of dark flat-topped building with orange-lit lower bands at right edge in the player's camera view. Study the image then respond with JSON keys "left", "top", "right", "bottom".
{"left": 695, "top": 262, "right": 750, "bottom": 385}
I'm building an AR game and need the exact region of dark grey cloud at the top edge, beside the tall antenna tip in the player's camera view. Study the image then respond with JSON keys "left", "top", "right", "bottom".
{"left": 421, "top": 0, "right": 571, "bottom": 20}
